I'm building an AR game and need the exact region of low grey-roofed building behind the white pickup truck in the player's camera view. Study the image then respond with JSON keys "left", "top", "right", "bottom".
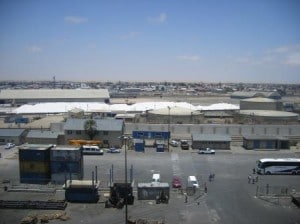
{"left": 192, "top": 134, "right": 231, "bottom": 149}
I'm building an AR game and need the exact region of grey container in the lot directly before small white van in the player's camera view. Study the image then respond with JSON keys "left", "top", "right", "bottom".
{"left": 137, "top": 182, "right": 170, "bottom": 200}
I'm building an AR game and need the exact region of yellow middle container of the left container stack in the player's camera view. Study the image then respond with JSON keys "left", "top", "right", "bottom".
{"left": 19, "top": 161, "right": 50, "bottom": 174}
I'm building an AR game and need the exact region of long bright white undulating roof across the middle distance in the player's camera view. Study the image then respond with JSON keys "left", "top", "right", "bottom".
{"left": 12, "top": 102, "right": 239, "bottom": 114}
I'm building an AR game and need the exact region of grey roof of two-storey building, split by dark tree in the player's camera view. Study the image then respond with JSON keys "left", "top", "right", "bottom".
{"left": 64, "top": 118, "right": 124, "bottom": 131}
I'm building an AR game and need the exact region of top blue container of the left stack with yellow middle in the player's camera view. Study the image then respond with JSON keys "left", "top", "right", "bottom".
{"left": 19, "top": 144, "right": 53, "bottom": 161}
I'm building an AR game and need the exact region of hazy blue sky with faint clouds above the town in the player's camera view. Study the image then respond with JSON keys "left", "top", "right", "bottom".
{"left": 0, "top": 0, "right": 300, "bottom": 84}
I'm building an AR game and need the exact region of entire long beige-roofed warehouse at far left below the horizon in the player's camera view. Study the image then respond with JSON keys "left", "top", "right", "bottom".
{"left": 0, "top": 89, "right": 110, "bottom": 106}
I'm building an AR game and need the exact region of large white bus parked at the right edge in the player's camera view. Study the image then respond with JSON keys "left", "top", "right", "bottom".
{"left": 257, "top": 158, "right": 300, "bottom": 175}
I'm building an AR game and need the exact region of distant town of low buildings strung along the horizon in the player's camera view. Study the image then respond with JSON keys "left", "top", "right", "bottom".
{"left": 0, "top": 80, "right": 300, "bottom": 98}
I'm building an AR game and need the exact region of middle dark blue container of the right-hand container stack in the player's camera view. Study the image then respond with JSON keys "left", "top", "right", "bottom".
{"left": 50, "top": 161, "right": 83, "bottom": 174}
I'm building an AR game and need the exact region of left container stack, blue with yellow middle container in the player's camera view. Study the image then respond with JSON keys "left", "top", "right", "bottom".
{"left": 19, "top": 144, "right": 53, "bottom": 184}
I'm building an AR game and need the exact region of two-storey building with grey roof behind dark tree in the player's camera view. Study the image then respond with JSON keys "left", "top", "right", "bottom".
{"left": 64, "top": 118, "right": 124, "bottom": 147}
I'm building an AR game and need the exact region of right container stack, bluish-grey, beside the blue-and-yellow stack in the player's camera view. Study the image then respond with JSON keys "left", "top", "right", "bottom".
{"left": 50, "top": 146, "right": 83, "bottom": 184}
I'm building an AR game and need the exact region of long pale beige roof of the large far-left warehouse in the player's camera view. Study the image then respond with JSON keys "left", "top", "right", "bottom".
{"left": 0, "top": 89, "right": 109, "bottom": 100}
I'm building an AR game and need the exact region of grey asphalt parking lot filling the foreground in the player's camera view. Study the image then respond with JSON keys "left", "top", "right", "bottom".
{"left": 0, "top": 144, "right": 300, "bottom": 224}
